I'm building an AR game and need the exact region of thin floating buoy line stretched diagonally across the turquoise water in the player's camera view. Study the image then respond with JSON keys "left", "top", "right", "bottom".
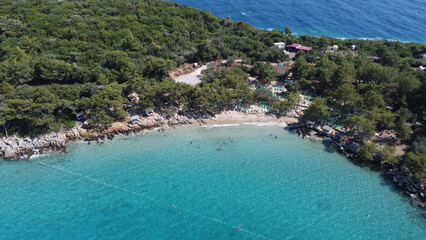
{"left": 37, "top": 162, "right": 272, "bottom": 240}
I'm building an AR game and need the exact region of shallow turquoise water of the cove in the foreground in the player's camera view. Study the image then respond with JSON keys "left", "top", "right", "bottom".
{"left": 0, "top": 126, "right": 426, "bottom": 239}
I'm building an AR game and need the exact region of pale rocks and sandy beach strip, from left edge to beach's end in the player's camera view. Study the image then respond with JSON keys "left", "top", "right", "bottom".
{"left": 0, "top": 110, "right": 299, "bottom": 161}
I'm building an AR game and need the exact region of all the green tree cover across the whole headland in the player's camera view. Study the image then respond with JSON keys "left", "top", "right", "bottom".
{"left": 0, "top": 0, "right": 426, "bottom": 182}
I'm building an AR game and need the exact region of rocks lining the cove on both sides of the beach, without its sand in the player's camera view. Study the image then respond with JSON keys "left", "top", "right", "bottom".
{"left": 0, "top": 112, "right": 426, "bottom": 208}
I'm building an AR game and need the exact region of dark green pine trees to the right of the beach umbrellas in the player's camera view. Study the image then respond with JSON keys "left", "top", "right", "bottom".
{"left": 292, "top": 41, "right": 426, "bottom": 181}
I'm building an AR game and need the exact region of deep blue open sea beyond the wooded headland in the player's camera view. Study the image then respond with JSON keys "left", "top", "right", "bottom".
{"left": 172, "top": 0, "right": 426, "bottom": 43}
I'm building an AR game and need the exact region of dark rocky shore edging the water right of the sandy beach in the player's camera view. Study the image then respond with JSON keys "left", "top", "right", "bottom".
{"left": 288, "top": 120, "right": 426, "bottom": 209}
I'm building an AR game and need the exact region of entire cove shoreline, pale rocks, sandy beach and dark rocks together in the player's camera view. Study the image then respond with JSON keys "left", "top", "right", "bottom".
{"left": 0, "top": 110, "right": 426, "bottom": 209}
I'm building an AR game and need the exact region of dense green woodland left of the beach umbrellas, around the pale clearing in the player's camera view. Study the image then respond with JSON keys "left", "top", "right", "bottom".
{"left": 0, "top": 0, "right": 285, "bottom": 135}
